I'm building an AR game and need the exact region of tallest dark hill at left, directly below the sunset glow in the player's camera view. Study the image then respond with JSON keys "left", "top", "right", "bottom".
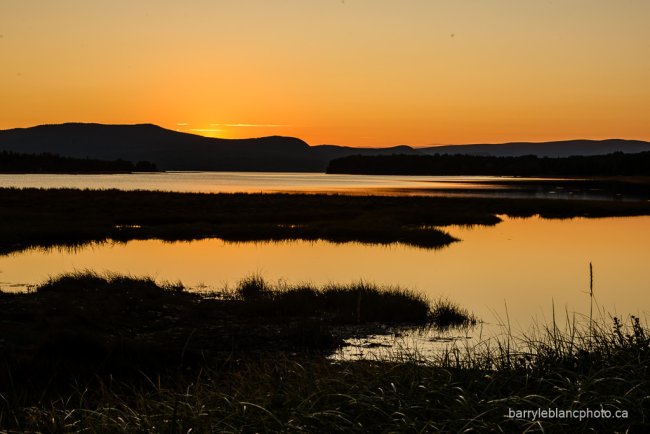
{"left": 0, "top": 123, "right": 314, "bottom": 171}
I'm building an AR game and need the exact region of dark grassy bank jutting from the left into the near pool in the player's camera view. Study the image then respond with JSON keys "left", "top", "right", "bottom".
{"left": 0, "top": 272, "right": 468, "bottom": 396}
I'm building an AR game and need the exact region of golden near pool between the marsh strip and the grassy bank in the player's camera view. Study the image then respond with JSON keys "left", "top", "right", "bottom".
{"left": 0, "top": 217, "right": 650, "bottom": 346}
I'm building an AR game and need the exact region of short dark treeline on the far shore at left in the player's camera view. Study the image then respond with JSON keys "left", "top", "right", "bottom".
{"left": 0, "top": 151, "right": 158, "bottom": 173}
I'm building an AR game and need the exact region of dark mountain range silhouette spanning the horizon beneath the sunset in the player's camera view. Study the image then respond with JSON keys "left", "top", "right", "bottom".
{"left": 0, "top": 123, "right": 650, "bottom": 172}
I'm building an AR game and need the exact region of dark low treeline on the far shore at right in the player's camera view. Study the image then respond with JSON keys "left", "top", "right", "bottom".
{"left": 327, "top": 152, "right": 650, "bottom": 177}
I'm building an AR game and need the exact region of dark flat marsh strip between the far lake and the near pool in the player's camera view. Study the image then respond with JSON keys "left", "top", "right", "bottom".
{"left": 0, "top": 188, "right": 650, "bottom": 253}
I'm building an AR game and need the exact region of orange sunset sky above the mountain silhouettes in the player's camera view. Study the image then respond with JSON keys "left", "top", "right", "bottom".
{"left": 0, "top": 0, "right": 650, "bottom": 146}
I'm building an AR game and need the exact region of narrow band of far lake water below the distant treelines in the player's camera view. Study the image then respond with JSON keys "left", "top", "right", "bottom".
{"left": 0, "top": 172, "right": 650, "bottom": 200}
